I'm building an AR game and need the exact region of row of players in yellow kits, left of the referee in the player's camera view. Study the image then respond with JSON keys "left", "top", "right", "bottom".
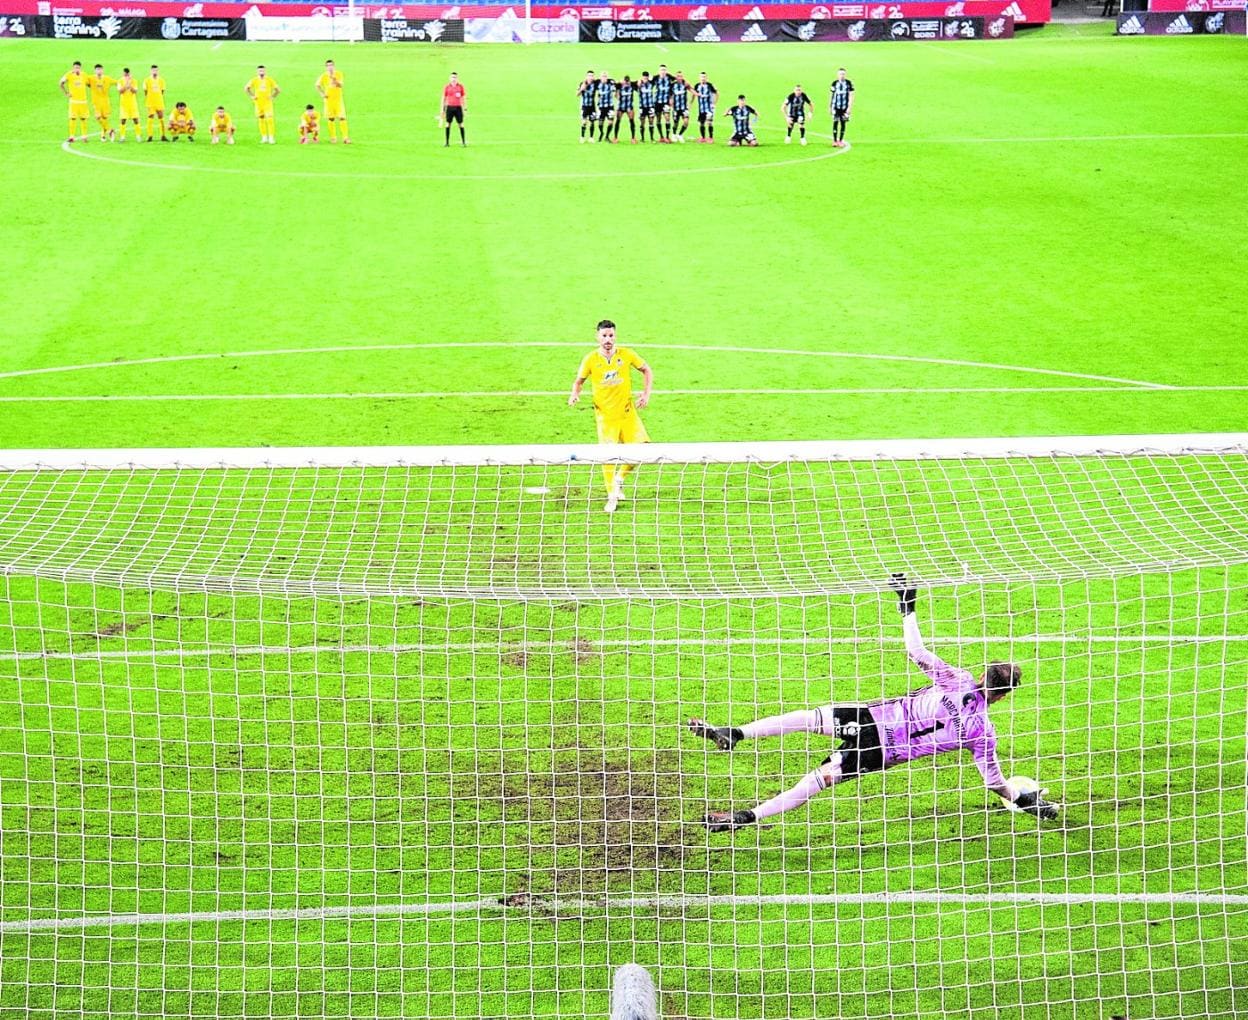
{"left": 61, "top": 60, "right": 351, "bottom": 145}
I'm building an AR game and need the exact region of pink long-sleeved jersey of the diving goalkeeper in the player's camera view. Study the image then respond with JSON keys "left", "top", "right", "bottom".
{"left": 867, "top": 613, "right": 1006, "bottom": 787}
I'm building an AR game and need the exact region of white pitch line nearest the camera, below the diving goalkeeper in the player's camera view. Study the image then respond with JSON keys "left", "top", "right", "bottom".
{"left": 0, "top": 891, "right": 1248, "bottom": 935}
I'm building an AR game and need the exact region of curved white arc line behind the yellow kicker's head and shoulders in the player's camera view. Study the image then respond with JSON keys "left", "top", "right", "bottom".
{"left": 0, "top": 340, "right": 1179, "bottom": 390}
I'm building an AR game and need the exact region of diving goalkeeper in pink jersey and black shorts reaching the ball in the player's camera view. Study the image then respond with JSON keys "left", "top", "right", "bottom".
{"left": 689, "top": 574, "right": 1057, "bottom": 833}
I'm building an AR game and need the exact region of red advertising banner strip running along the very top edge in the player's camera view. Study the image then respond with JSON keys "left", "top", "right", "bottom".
{"left": 0, "top": 0, "right": 1053, "bottom": 25}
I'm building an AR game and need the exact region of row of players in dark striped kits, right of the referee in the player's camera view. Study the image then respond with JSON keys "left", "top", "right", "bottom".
{"left": 577, "top": 64, "right": 854, "bottom": 149}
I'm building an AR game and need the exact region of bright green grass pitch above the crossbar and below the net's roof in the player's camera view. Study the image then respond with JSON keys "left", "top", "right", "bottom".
{"left": 0, "top": 26, "right": 1248, "bottom": 1020}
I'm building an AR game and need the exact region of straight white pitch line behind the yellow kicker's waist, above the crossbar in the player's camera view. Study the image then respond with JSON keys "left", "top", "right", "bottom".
{"left": 0, "top": 386, "right": 1248, "bottom": 403}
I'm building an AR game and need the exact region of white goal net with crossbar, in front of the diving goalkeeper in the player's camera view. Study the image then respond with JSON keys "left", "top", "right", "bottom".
{"left": 0, "top": 436, "right": 1248, "bottom": 1020}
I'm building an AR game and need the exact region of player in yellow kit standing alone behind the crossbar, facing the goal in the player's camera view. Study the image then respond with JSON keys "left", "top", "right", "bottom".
{"left": 568, "top": 318, "right": 654, "bottom": 513}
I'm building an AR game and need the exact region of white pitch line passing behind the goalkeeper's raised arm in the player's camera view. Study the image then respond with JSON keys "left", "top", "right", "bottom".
{"left": 0, "top": 632, "right": 1248, "bottom": 662}
